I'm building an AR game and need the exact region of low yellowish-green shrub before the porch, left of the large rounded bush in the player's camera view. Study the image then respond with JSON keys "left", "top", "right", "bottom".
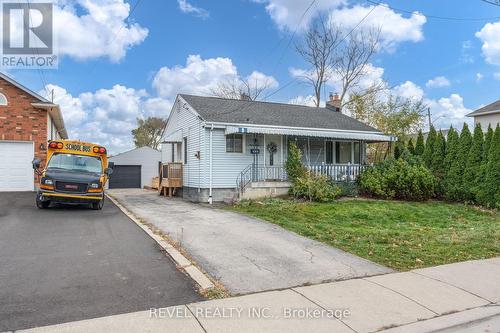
{"left": 290, "top": 172, "right": 342, "bottom": 202}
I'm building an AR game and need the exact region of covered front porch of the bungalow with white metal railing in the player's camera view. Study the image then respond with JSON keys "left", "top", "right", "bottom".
{"left": 236, "top": 133, "right": 374, "bottom": 193}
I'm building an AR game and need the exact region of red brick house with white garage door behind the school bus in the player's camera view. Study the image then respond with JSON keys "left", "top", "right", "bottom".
{"left": 0, "top": 73, "right": 68, "bottom": 191}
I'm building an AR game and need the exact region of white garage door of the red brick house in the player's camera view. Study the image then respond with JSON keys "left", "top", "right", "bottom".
{"left": 0, "top": 141, "right": 34, "bottom": 191}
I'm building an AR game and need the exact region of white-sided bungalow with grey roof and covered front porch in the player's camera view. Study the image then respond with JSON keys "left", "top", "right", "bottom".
{"left": 162, "top": 94, "right": 392, "bottom": 203}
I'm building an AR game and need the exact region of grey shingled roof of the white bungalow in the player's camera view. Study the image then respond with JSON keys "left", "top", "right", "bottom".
{"left": 180, "top": 94, "right": 380, "bottom": 132}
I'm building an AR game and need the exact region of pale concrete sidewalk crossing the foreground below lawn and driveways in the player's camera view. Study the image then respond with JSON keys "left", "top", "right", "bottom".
{"left": 14, "top": 258, "right": 500, "bottom": 333}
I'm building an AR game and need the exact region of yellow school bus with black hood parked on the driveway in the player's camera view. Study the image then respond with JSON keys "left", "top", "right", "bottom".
{"left": 33, "top": 140, "right": 113, "bottom": 210}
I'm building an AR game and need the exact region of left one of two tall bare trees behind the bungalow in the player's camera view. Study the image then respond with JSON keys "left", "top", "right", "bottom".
{"left": 295, "top": 16, "right": 341, "bottom": 107}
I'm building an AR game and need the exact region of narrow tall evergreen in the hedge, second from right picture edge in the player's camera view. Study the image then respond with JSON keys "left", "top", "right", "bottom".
{"left": 464, "top": 124, "right": 484, "bottom": 201}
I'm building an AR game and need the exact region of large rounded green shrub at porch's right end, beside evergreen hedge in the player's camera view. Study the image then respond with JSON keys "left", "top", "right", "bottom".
{"left": 359, "top": 158, "right": 437, "bottom": 201}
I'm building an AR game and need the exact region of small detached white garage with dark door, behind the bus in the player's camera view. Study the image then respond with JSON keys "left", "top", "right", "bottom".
{"left": 109, "top": 147, "right": 161, "bottom": 189}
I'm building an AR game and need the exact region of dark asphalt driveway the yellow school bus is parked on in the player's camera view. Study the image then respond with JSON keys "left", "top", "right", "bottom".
{"left": 0, "top": 192, "right": 201, "bottom": 332}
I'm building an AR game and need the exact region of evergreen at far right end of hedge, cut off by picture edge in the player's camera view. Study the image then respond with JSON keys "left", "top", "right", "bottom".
{"left": 478, "top": 124, "right": 500, "bottom": 208}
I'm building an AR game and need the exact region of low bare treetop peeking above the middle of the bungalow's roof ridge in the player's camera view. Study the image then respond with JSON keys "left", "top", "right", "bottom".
{"left": 210, "top": 77, "right": 274, "bottom": 101}
